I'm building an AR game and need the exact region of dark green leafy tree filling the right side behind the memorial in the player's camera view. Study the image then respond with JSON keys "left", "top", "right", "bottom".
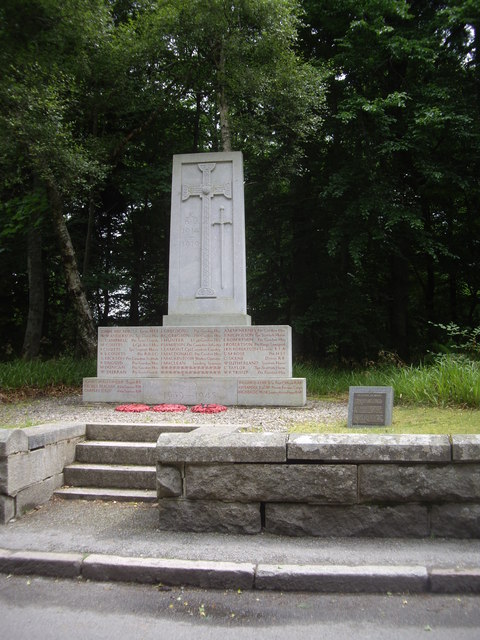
{"left": 290, "top": 0, "right": 479, "bottom": 357}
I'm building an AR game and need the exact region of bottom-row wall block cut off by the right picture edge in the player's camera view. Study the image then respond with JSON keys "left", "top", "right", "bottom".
{"left": 431, "top": 504, "right": 480, "bottom": 538}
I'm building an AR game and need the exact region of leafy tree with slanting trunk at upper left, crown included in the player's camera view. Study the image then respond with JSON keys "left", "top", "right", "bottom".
{"left": 0, "top": 0, "right": 108, "bottom": 355}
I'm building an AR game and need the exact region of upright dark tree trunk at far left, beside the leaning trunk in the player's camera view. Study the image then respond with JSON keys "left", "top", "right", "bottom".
{"left": 22, "top": 221, "right": 45, "bottom": 360}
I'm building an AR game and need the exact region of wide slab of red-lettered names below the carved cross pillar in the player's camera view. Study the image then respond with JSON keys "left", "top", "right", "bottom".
{"left": 97, "top": 326, "right": 292, "bottom": 378}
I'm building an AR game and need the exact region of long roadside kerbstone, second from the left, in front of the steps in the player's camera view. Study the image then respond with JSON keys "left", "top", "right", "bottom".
{"left": 82, "top": 554, "right": 255, "bottom": 589}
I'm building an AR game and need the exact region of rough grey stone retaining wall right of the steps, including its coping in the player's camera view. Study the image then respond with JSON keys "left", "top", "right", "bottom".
{"left": 157, "top": 426, "right": 480, "bottom": 538}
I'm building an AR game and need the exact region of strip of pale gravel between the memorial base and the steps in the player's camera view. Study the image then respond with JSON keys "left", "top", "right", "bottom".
{"left": 0, "top": 394, "right": 347, "bottom": 431}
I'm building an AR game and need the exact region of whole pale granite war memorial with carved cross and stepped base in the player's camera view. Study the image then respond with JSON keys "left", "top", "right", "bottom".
{"left": 83, "top": 152, "right": 306, "bottom": 406}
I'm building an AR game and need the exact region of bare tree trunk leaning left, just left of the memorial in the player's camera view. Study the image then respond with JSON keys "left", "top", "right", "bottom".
{"left": 48, "top": 183, "right": 96, "bottom": 357}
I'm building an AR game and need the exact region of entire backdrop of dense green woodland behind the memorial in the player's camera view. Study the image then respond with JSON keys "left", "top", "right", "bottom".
{"left": 0, "top": 0, "right": 480, "bottom": 362}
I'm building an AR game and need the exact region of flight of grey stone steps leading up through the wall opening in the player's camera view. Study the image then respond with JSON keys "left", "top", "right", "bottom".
{"left": 55, "top": 424, "right": 169, "bottom": 502}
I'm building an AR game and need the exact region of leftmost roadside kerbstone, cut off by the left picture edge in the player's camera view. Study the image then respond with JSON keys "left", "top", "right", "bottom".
{"left": 0, "top": 551, "right": 83, "bottom": 578}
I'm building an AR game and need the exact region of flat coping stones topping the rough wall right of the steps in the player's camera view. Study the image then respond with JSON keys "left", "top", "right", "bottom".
{"left": 157, "top": 425, "right": 480, "bottom": 463}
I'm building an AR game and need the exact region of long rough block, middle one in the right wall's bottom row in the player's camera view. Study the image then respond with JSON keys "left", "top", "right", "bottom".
{"left": 265, "top": 503, "right": 430, "bottom": 538}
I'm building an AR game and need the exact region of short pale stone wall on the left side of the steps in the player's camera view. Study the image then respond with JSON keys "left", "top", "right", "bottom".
{"left": 0, "top": 423, "right": 85, "bottom": 524}
